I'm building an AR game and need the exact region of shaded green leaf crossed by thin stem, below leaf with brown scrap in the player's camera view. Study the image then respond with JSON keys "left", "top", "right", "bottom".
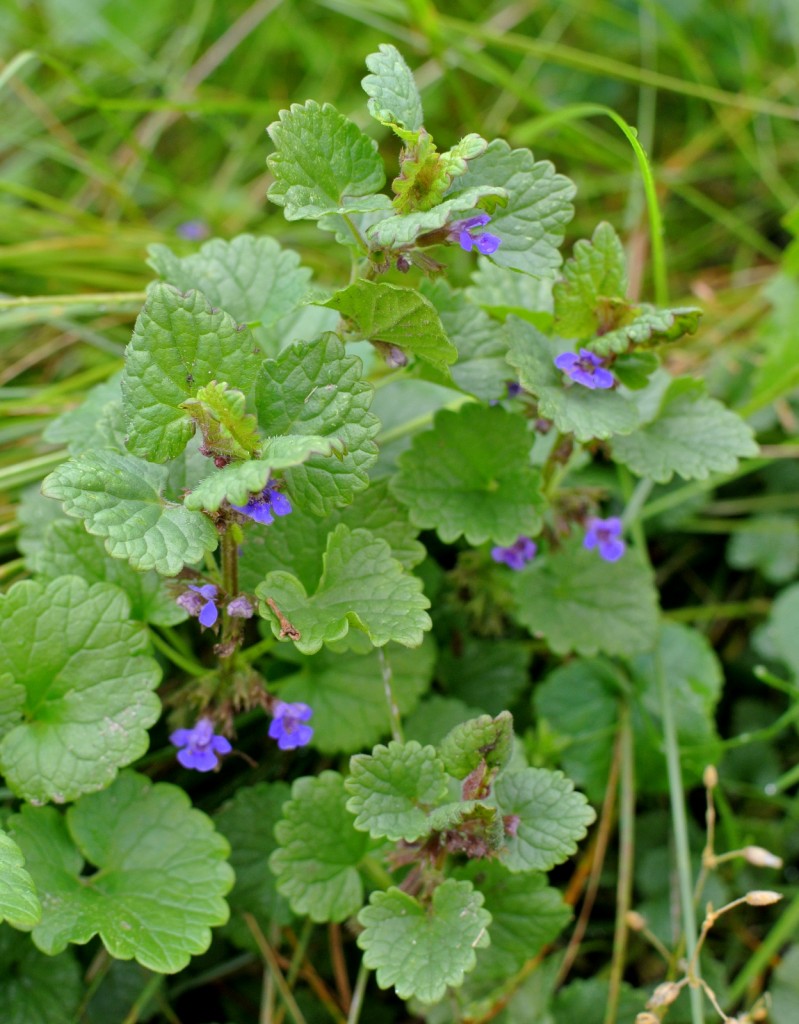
{"left": 275, "top": 637, "right": 435, "bottom": 754}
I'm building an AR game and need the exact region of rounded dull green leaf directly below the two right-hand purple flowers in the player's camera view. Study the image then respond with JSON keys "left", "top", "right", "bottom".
{"left": 510, "top": 544, "right": 658, "bottom": 655}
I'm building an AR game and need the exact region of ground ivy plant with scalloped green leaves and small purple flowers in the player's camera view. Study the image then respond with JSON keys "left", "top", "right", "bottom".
{"left": 0, "top": 45, "right": 757, "bottom": 1016}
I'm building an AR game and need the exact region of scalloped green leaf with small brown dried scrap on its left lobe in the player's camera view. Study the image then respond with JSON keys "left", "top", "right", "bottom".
{"left": 256, "top": 523, "right": 430, "bottom": 654}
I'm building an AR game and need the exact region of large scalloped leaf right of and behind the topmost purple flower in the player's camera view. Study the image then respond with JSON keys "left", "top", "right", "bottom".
{"left": 453, "top": 139, "right": 575, "bottom": 278}
